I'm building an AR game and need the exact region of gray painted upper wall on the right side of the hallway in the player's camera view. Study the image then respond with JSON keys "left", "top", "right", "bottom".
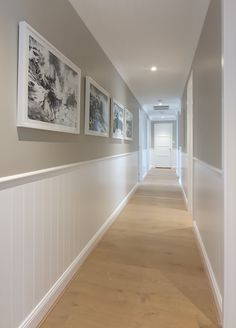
{"left": 182, "top": 0, "right": 222, "bottom": 168}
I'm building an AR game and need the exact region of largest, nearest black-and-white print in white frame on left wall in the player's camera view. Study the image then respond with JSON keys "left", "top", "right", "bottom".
{"left": 17, "top": 22, "right": 81, "bottom": 133}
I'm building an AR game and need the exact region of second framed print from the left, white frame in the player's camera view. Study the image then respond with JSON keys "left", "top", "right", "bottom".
{"left": 85, "top": 76, "right": 110, "bottom": 137}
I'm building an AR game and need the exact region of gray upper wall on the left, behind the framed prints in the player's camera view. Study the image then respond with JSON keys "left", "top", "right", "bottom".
{"left": 0, "top": 0, "right": 140, "bottom": 176}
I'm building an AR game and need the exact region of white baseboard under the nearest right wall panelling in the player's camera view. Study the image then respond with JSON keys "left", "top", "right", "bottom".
{"left": 193, "top": 221, "right": 223, "bottom": 325}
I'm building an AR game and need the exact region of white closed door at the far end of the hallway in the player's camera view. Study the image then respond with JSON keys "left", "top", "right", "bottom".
{"left": 153, "top": 123, "right": 173, "bottom": 168}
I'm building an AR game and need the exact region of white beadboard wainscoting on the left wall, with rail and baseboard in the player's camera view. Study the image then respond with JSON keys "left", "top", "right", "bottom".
{"left": 0, "top": 152, "right": 138, "bottom": 328}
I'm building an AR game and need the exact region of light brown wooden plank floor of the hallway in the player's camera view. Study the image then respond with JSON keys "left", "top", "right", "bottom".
{"left": 41, "top": 169, "right": 218, "bottom": 328}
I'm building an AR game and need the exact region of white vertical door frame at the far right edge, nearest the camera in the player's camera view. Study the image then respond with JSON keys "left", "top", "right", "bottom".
{"left": 222, "top": 0, "right": 236, "bottom": 328}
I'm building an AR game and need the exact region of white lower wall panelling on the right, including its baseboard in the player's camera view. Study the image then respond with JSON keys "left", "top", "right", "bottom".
{"left": 193, "top": 158, "right": 224, "bottom": 320}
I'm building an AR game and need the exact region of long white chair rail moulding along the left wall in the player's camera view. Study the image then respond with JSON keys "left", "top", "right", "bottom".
{"left": 0, "top": 152, "right": 137, "bottom": 190}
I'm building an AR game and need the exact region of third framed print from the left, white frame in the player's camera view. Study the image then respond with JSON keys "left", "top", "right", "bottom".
{"left": 111, "top": 99, "right": 125, "bottom": 139}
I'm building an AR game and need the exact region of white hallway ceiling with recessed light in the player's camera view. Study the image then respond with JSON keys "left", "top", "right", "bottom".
{"left": 69, "top": 0, "right": 209, "bottom": 119}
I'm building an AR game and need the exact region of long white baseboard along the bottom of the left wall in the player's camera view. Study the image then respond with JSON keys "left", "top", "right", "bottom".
{"left": 18, "top": 183, "right": 139, "bottom": 328}
